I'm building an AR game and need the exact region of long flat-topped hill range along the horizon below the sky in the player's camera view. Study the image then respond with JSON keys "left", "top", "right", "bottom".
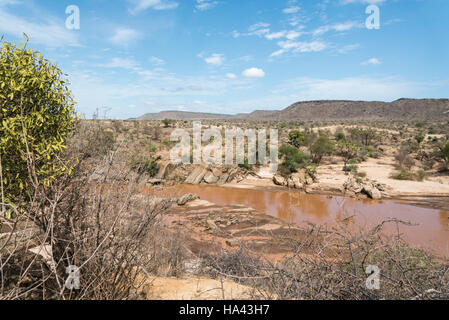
{"left": 138, "top": 99, "right": 449, "bottom": 121}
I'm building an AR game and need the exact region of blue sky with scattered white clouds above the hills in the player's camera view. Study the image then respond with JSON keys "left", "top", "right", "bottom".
{"left": 0, "top": 0, "right": 449, "bottom": 118}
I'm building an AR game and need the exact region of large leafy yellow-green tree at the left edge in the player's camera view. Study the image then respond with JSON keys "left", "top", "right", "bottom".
{"left": 0, "top": 38, "right": 78, "bottom": 205}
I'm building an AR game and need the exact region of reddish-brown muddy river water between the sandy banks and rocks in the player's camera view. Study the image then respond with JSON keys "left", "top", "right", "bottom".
{"left": 166, "top": 185, "right": 449, "bottom": 258}
